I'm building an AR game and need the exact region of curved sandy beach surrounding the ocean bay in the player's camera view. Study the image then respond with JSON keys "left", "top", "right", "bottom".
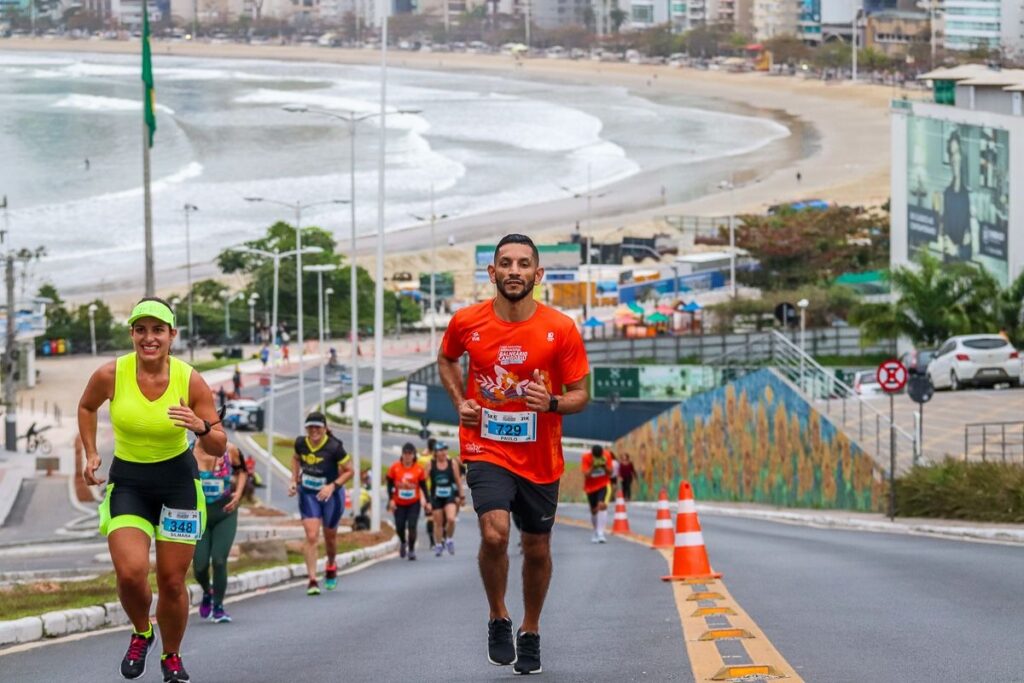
{"left": 6, "top": 39, "right": 905, "bottom": 309}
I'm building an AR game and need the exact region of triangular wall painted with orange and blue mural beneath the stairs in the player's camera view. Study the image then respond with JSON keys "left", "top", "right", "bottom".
{"left": 598, "top": 370, "right": 886, "bottom": 511}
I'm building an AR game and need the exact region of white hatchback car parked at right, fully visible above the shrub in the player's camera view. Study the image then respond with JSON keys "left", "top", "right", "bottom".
{"left": 928, "top": 335, "right": 1021, "bottom": 391}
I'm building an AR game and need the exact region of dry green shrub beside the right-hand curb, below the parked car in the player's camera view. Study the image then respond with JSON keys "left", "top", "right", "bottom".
{"left": 896, "top": 458, "right": 1024, "bottom": 523}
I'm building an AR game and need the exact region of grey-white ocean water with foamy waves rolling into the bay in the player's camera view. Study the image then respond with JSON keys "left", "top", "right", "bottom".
{"left": 0, "top": 50, "right": 790, "bottom": 291}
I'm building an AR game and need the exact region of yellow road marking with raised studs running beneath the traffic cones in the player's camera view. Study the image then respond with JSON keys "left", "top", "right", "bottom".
{"left": 556, "top": 515, "right": 804, "bottom": 683}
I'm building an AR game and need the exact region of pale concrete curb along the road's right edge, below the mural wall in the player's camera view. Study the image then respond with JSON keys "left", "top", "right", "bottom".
{"left": 631, "top": 501, "right": 1024, "bottom": 545}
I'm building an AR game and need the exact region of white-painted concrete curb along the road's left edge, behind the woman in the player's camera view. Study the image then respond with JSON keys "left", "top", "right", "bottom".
{"left": 0, "top": 538, "right": 398, "bottom": 646}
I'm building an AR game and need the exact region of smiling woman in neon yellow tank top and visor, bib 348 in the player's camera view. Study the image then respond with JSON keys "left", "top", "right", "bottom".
{"left": 78, "top": 297, "right": 227, "bottom": 683}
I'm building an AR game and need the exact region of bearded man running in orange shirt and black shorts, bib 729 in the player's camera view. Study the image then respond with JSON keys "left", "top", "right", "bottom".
{"left": 437, "top": 234, "right": 590, "bottom": 674}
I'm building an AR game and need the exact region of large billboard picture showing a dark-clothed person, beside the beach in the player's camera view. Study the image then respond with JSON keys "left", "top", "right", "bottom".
{"left": 906, "top": 116, "right": 1010, "bottom": 285}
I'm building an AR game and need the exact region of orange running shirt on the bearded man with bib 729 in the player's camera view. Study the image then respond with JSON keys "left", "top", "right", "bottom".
{"left": 441, "top": 301, "right": 590, "bottom": 483}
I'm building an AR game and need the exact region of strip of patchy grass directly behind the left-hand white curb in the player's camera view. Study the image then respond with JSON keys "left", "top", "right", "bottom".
{"left": 0, "top": 526, "right": 394, "bottom": 621}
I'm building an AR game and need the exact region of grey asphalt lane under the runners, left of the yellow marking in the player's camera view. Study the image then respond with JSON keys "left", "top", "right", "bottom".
{"left": 0, "top": 512, "right": 692, "bottom": 683}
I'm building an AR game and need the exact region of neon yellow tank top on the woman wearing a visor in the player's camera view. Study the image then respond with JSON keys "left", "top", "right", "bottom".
{"left": 111, "top": 352, "right": 193, "bottom": 463}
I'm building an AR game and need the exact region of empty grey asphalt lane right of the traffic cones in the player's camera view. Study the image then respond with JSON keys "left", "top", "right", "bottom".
{"left": 559, "top": 506, "right": 1024, "bottom": 683}
